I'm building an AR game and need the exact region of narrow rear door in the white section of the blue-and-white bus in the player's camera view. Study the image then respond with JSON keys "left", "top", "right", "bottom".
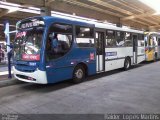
{"left": 133, "top": 35, "right": 138, "bottom": 64}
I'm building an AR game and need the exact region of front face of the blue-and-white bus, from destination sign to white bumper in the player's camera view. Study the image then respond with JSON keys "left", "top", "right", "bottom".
{"left": 13, "top": 18, "right": 47, "bottom": 84}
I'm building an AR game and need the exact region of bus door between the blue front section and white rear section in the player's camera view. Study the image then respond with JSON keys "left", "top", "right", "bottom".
{"left": 95, "top": 31, "right": 105, "bottom": 72}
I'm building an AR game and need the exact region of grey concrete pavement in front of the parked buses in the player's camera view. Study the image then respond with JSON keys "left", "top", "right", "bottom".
{"left": 0, "top": 62, "right": 160, "bottom": 114}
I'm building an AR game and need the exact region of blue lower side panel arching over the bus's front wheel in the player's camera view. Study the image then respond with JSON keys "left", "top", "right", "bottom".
{"left": 46, "top": 48, "right": 96, "bottom": 83}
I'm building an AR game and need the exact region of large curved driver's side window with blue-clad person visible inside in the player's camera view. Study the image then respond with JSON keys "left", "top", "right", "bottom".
{"left": 46, "top": 23, "right": 72, "bottom": 61}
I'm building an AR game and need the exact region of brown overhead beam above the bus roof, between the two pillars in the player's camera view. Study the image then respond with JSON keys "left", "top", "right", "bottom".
{"left": 50, "top": 1, "right": 119, "bottom": 24}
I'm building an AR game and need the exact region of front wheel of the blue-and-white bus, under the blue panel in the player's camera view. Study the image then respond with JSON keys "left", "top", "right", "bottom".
{"left": 73, "top": 65, "right": 85, "bottom": 83}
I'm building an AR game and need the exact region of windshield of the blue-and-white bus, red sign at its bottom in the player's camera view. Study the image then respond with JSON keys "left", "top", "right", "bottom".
{"left": 14, "top": 28, "right": 43, "bottom": 61}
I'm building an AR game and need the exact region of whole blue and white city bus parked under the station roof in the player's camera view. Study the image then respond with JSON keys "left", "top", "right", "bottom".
{"left": 13, "top": 16, "right": 145, "bottom": 84}
